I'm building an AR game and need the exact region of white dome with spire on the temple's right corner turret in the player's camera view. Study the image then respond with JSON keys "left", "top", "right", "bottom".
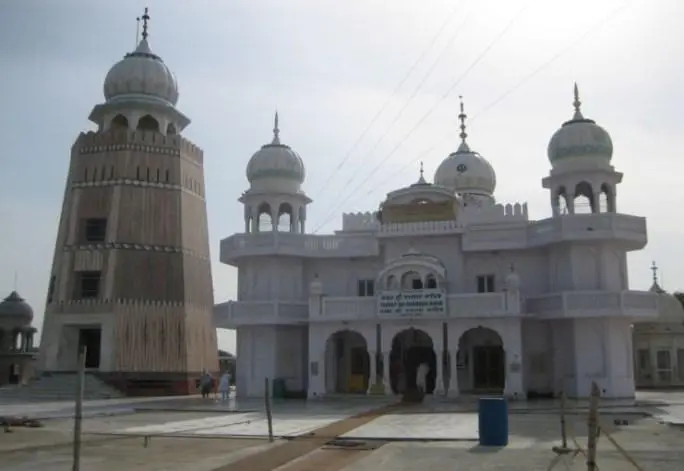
{"left": 548, "top": 84, "right": 613, "bottom": 167}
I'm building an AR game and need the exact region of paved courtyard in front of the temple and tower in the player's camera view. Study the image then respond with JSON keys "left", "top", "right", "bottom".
{"left": 0, "top": 393, "right": 684, "bottom": 471}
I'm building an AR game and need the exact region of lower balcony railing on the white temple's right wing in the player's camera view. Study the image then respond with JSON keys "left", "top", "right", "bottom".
{"left": 526, "top": 291, "right": 658, "bottom": 318}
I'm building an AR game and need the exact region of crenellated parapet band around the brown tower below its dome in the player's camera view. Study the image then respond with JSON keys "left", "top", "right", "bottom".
{"left": 74, "top": 130, "right": 204, "bottom": 164}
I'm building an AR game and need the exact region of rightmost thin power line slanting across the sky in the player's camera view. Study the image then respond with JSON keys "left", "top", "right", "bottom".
{"left": 325, "top": 1, "right": 636, "bottom": 218}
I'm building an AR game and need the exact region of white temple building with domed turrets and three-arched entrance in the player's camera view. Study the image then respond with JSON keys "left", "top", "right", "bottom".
{"left": 214, "top": 87, "right": 659, "bottom": 398}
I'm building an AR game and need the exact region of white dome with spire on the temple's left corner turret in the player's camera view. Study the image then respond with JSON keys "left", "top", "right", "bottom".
{"left": 247, "top": 113, "right": 306, "bottom": 186}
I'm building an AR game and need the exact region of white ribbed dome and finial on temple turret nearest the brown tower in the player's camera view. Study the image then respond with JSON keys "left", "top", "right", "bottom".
{"left": 247, "top": 112, "right": 306, "bottom": 192}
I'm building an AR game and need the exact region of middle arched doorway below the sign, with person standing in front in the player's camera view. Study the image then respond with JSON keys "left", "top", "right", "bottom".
{"left": 390, "top": 327, "right": 437, "bottom": 394}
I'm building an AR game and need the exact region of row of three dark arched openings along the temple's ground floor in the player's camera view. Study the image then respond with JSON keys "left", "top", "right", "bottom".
{"left": 325, "top": 327, "right": 506, "bottom": 394}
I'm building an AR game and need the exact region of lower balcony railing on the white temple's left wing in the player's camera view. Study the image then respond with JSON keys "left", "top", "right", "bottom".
{"left": 214, "top": 301, "right": 309, "bottom": 329}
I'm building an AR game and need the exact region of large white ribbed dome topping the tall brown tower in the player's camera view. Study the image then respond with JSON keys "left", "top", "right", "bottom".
{"left": 104, "top": 37, "right": 178, "bottom": 105}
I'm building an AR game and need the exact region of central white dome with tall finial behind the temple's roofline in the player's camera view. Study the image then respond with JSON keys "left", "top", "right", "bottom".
{"left": 434, "top": 97, "right": 496, "bottom": 197}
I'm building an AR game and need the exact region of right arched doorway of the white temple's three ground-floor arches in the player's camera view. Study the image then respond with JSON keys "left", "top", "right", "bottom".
{"left": 457, "top": 327, "right": 506, "bottom": 394}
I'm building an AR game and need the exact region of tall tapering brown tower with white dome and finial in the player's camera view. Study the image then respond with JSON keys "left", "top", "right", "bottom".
{"left": 39, "top": 10, "right": 218, "bottom": 394}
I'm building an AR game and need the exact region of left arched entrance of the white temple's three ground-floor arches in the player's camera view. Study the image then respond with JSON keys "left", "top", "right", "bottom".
{"left": 325, "top": 330, "right": 370, "bottom": 394}
